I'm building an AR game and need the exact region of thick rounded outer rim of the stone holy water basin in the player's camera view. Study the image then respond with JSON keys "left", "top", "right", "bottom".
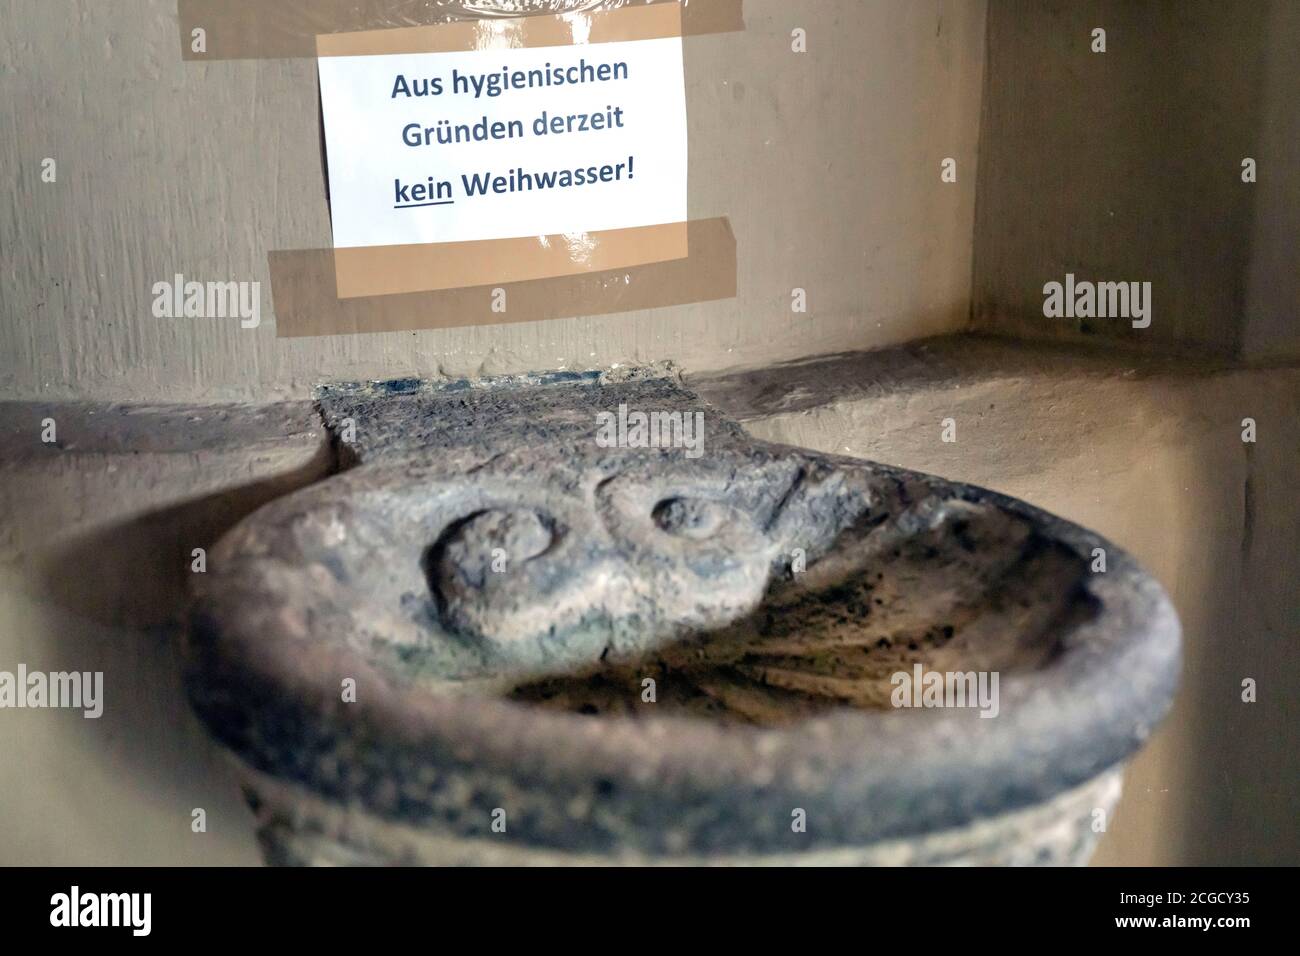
{"left": 190, "top": 460, "right": 1179, "bottom": 842}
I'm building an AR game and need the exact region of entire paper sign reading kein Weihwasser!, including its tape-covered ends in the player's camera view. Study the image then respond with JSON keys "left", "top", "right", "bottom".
{"left": 317, "top": 4, "right": 689, "bottom": 298}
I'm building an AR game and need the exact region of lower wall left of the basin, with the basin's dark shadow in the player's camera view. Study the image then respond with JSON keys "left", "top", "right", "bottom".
{"left": 0, "top": 403, "right": 334, "bottom": 865}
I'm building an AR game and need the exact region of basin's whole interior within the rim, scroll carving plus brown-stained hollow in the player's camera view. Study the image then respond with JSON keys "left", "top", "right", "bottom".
{"left": 224, "top": 453, "right": 1093, "bottom": 724}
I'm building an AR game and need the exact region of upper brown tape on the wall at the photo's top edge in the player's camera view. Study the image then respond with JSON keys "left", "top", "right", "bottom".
{"left": 177, "top": 0, "right": 745, "bottom": 60}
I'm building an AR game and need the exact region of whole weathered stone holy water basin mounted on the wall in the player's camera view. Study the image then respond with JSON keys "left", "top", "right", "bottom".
{"left": 187, "top": 378, "right": 1179, "bottom": 865}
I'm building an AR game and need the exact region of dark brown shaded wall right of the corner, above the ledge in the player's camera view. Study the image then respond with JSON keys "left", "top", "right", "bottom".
{"left": 972, "top": 0, "right": 1300, "bottom": 359}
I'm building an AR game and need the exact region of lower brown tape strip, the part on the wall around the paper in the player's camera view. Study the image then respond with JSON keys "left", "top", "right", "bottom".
{"left": 269, "top": 219, "right": 736, "bottom": 337}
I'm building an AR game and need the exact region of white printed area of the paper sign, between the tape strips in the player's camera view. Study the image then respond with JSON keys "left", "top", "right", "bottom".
{"left": 319, "top": 36, "right": 686, "bottom": 248}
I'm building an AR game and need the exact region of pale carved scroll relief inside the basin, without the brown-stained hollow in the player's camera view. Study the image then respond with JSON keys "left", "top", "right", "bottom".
{"left": 195, "top": 451, "right": 879, "bottom": 688}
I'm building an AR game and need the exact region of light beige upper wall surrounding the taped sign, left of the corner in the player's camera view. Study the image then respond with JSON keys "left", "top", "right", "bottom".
{"left": 0, "top": 0, "right": 984, "bottom": 401}
